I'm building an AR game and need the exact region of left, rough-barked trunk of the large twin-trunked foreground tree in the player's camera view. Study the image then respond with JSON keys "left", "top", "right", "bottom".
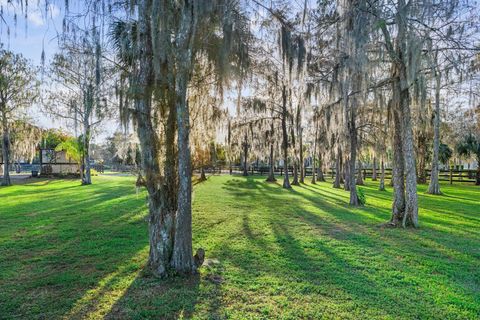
{"left": 134, "top": 0, "right": 176, "bottom": 277}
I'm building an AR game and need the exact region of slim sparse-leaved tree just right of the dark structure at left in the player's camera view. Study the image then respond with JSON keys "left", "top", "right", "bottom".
{"left": 44, "top": 29, "right": 113, "bottom": 185}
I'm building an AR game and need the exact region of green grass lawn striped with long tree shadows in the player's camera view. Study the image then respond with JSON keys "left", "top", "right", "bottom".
{"left": 0, "top": 176, "right": 480, "bottom": 319}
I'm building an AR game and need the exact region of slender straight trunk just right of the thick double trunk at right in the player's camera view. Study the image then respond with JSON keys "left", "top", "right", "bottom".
{"left": 427, "top": 71, "right": 442, "bottom": 194}
